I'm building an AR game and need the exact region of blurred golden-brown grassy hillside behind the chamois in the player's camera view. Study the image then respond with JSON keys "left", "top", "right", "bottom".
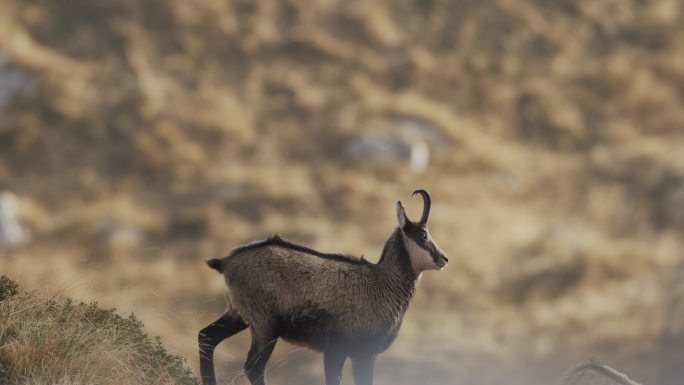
{"left": 0, "top": 0, "right": 684, "bottom": 385}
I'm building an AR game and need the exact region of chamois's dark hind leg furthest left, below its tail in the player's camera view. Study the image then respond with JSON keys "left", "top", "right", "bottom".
{"left": 198, "top": 312, "right": 247, "bottom": 385}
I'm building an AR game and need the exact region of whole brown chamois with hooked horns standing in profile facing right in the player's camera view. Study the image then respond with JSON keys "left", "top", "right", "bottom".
{"left": 199, "top": 190, "right": 448, "bottom": 385}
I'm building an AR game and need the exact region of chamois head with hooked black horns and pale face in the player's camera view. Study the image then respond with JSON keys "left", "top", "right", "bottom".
{"left": 397, "top": 190, "right": 449, "bottom": 274}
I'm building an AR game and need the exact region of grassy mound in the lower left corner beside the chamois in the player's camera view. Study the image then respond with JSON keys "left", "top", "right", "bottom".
{"left": 0, "top": 276, "right": 197, "bottom": 385}
